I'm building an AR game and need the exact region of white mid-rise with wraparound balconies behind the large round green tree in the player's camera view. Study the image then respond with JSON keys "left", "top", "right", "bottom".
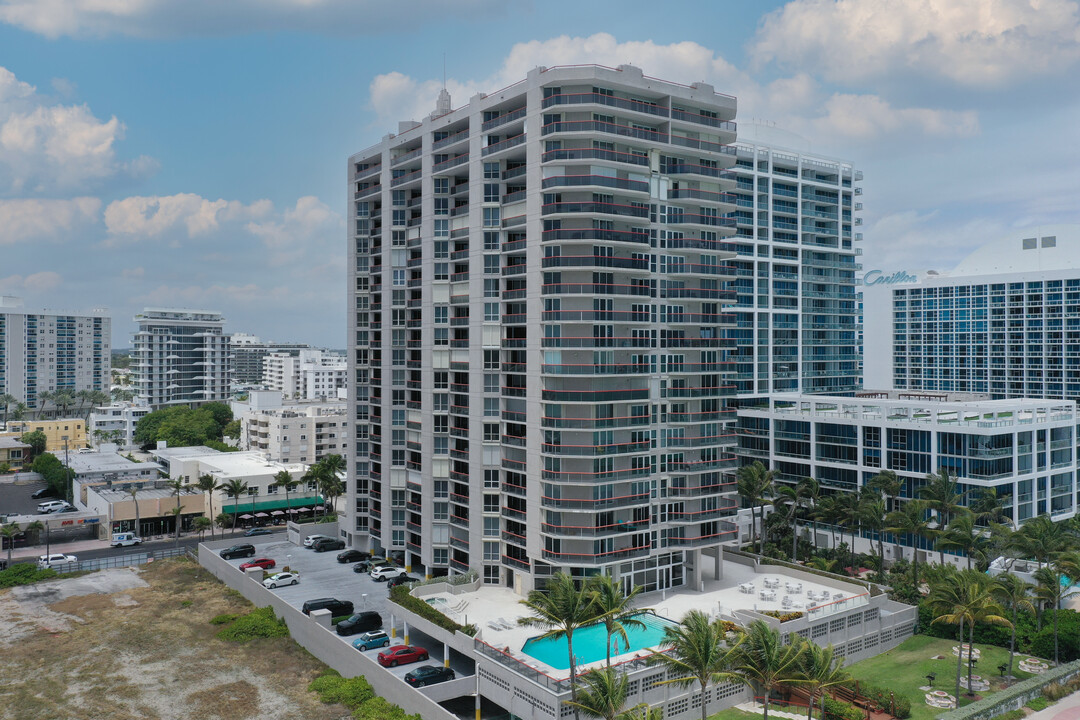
{"left": 132, "top": 308, "right": 232, "bottom": 409}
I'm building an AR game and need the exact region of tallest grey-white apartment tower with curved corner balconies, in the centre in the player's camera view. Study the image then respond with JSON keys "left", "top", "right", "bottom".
{"left": 342, "top": 66, "right": 737, "bottom": 593}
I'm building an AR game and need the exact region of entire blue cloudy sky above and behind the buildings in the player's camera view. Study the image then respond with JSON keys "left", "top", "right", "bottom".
{"left": 0, "top": 0, "right": 1080, "bottom": 348}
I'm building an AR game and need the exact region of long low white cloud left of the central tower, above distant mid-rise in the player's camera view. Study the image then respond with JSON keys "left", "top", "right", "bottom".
{"left": 105, "top": 192, "right": 273, "bottom": 245}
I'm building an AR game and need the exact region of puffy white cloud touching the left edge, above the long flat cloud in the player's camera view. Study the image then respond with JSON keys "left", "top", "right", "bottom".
{"left": 0, "top": 67, "right": 157, "bottom": 194}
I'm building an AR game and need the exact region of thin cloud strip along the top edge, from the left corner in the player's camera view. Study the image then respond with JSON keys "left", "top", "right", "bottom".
{"left": 0, "top": 0, "right": 516, "bottom": 38}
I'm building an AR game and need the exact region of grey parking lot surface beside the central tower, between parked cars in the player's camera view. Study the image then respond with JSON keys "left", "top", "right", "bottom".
{"left": 212, "top": 534, "right": 473, "bottom": 678}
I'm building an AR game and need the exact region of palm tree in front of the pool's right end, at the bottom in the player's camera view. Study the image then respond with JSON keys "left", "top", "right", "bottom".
{"left": 648, "top": 610, "right": 745, "bottom": 720}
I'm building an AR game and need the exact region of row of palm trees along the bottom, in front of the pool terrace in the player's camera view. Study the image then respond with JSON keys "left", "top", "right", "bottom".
{"left": 518, "top": 573, "right": 851, "bottom": 720}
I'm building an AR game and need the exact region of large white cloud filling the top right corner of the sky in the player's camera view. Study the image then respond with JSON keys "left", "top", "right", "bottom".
{"left": 751, "top": 0, "right": 1080, "bottom": 87}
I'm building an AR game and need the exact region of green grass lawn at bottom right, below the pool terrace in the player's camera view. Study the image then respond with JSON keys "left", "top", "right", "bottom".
{"left": 846, "top": 635, "right": 1031, "bottom": 720}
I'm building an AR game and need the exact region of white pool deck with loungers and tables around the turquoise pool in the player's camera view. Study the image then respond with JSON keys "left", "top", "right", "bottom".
{"left": 412, "top": 561, "right": 867, "bottom": 678}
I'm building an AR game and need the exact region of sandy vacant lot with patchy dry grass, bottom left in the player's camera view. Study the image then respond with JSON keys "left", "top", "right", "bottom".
{"left": 0, "top": 560, "right": 348, "bottom": 720}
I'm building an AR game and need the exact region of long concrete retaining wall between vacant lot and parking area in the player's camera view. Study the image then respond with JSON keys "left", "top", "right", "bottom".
{"left": 199, "top": 544, "right": 458, "bottom": 720}
